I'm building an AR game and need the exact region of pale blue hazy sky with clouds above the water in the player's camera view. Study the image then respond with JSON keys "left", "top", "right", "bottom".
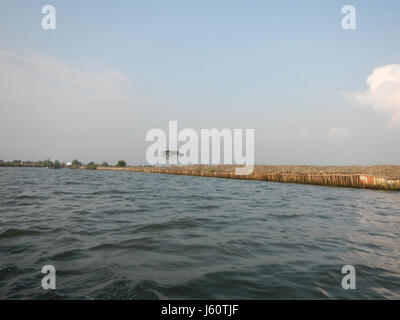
{"left": 0, "top": 0, "right": 400, "bottom": 165}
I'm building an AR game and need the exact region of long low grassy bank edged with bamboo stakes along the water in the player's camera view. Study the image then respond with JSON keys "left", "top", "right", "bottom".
{"left": 0, "top": 162, "right": 400, "bottom": 191}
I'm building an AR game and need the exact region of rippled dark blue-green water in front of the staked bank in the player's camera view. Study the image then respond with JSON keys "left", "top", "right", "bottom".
{"left": 0, "top": 168, "right": 400, "bottom": 299}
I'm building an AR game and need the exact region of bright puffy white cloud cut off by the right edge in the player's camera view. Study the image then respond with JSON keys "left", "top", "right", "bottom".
{"left": 350, "top": 64, "right": 400, "bottom": 128}
